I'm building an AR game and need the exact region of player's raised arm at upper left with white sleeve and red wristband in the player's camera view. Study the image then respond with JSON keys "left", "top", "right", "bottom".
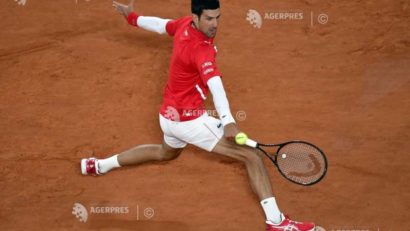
{"left": 112, "top": 0, "right": 170, "bottom": 34}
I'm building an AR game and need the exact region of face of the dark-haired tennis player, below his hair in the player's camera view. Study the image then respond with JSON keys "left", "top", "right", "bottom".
{"left": 194, "top": 9, "right": 221, "bottom": 38}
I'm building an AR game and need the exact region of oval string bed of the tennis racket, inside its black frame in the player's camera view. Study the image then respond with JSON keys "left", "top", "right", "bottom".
{"left": 276, "top": 142, "right": 326, "bottom": 184}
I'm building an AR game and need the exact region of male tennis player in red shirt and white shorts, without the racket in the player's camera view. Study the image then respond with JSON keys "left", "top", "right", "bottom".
{"left": 81, "top": 0, "right": 315, "bottom": 231}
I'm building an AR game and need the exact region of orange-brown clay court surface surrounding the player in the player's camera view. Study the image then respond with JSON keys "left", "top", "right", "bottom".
{"left": 0, "top": 0, "right": 410, "bottom": 231}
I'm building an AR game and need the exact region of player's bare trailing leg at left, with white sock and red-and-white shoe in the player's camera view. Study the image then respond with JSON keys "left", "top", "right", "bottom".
{"left": 81, "top": 141, "right": 183, "bottom": 175}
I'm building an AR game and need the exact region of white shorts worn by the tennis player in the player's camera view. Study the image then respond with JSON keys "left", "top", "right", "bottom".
{"left": 159, "top": 113, "right": 224, "bottom": 152}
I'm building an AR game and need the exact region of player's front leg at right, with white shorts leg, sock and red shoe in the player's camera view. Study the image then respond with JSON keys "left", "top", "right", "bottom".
{"left": 184, "top": 116, "right": 315, "bottom": 231}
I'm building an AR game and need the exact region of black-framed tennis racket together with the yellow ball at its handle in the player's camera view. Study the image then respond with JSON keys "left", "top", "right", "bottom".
{"left": 235, "top": 133, "right": 327, "bottom": 186}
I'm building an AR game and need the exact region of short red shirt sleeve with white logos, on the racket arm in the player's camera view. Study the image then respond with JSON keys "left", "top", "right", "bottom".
{"left": 195, "top": 44, "right": 222, "bottom": 85}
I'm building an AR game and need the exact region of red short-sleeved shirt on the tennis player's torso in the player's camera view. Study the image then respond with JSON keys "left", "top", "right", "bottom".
{"left": 160, "top": 16, "right": 221, "bottom": 121}
